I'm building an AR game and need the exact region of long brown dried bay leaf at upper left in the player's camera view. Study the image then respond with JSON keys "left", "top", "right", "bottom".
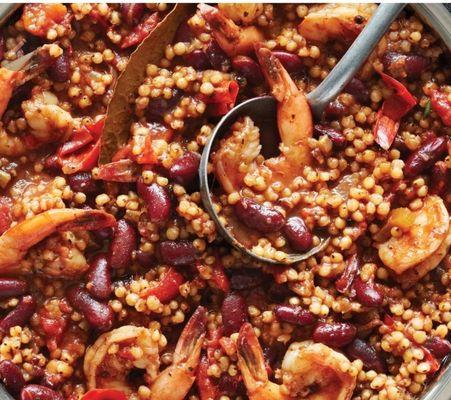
{"left": 99, "top": 4, "right": 193, "bottom": 164}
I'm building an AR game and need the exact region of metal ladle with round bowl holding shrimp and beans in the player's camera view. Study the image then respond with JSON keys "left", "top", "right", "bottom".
{"left": 199, "top": 3, "right": 405, "bottom": 264}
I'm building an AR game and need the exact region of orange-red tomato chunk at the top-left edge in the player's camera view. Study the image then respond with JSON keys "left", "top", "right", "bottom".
{"left": 22, "top": 3, "right": 71, "bottom": 38}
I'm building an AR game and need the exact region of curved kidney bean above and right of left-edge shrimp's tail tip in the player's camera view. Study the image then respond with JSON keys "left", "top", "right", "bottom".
{"left": 136, "top": 180, "right": 171, "bottom": 224}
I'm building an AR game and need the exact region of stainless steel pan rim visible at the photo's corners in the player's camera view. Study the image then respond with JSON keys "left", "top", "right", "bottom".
{"left": 0, "top": 3, "right": 451, "bottom": 400}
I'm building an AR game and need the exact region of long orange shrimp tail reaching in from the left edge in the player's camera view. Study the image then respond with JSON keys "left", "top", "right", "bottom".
{"left": 0, "top": 208, "right": 116, "bottom": 274}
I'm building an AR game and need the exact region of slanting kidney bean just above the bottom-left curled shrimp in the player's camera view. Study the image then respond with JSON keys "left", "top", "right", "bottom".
{"left": 66, "top": 286, "right": 114, "bottom": 331}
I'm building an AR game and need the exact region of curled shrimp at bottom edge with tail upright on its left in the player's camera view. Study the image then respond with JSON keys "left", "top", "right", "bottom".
{"left": 237, "top": 323, "right": 356, "bottom": 400}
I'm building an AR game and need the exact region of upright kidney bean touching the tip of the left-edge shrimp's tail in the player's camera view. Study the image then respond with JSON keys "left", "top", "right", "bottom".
{"left": 110, "top": 219, "right": 137, "bottom": 269}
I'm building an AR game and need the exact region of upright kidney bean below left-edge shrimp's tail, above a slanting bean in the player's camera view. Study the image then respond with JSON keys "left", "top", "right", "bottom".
{"left": 86, "top": 253, "right": 112, "bottom": 300}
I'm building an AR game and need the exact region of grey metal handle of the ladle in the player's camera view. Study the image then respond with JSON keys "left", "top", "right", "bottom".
{"left": 307, "top": 3, "right": 405, "bottom": 119}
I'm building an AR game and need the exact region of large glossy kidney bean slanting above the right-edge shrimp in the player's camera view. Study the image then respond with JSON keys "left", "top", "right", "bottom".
{"left": 404, "top": 136, "right": 447, "bottom": 178}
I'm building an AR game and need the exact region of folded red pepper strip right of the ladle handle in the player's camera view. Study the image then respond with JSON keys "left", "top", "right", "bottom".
{"left": 373, "top": 72, "right": 417, "bottom": 150}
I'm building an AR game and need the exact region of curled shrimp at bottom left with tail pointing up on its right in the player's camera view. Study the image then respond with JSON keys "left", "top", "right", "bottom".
{"left": 83, "top": 307, "right": 207, "bottom": 400}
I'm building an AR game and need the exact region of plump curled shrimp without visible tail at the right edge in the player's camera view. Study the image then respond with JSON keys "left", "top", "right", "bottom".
{"left": 378, "top": 196, "right": 450, "bottom": 276}
